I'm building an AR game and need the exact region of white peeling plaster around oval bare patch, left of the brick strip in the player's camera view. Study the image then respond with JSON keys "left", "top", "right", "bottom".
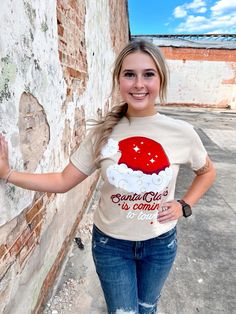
{"left": 0, "top": 0, "right": 66, "bottom": 225}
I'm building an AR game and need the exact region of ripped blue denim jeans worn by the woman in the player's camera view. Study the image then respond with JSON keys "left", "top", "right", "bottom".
{"left": 92, "top": 226, "right": 177, "bottom": 314}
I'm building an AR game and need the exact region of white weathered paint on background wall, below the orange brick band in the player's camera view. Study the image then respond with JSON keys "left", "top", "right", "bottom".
{"left": 167, "top": 59, "right": 236, "bottom": 109}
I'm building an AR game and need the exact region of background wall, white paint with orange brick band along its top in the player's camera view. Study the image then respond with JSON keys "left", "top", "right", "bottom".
{"left": 161, "top": 47, "right": 236, "bottom": 109}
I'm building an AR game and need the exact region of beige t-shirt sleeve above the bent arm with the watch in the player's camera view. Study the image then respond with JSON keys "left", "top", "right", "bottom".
{"left": 188, "top": 128, "right": 207, "bottom": 171}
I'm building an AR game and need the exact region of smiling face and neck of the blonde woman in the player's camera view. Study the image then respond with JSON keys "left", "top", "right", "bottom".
{"left": 118, "top": 52, "right": 160, "bottom": 117}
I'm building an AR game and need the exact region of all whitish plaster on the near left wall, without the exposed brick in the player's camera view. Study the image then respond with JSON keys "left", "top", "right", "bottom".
{"left": 0, "top": 0, "right": 125, "bottom": 314}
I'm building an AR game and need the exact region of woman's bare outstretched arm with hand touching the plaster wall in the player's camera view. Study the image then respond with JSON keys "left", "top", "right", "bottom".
{"left": 0, "top": 134, "right": 87, "bottom": 193}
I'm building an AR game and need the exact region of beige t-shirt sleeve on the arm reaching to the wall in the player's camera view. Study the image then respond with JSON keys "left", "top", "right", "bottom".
{"left": 70, "top": 133, "right": 97, "bottom": 176}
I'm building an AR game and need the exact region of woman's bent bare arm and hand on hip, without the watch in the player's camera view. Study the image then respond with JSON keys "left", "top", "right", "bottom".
{"left": 157, "top": 156, "right": 216, "bottom": 223}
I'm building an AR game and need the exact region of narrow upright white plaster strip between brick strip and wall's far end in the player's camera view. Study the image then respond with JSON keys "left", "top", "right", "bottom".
{"left": 77, "top": 0, "right": 115, "bottom": 119}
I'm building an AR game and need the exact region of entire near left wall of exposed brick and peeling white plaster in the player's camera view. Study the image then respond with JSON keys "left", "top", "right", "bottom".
{"left": 0, "top": 0, "right": 129, "bottom": 314}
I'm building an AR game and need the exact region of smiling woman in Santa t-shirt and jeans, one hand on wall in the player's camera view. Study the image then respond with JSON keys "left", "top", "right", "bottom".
{"left": 0, "top": 41, "right": 215, "bottom": 314}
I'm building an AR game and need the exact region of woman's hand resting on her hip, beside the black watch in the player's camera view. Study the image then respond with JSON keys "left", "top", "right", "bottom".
{"left": 157, "top": 200, "right": 183, "bottom": 223}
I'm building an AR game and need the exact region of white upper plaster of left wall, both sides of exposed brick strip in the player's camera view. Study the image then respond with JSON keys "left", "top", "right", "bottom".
{"left": 0, "top": 0, "right": 114, "bottom": 225}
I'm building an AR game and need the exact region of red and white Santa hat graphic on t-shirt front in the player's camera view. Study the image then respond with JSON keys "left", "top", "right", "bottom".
{"left": 102, "top": 136, "right": 172, "bottom": 194}
